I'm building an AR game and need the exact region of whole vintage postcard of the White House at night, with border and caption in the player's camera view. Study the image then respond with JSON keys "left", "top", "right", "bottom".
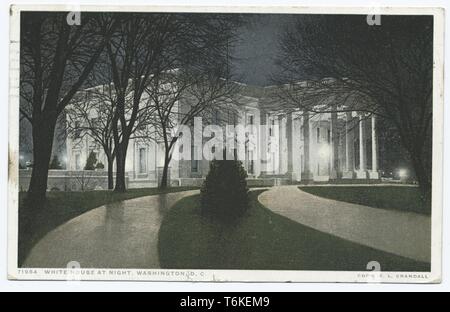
{"left": 8, "top": 5, "right": 444, "bottom": 283}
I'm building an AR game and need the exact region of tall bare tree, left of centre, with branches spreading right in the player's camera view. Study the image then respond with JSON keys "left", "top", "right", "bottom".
{"left": 107, "top": 14, "right": 243, "bottom": 192}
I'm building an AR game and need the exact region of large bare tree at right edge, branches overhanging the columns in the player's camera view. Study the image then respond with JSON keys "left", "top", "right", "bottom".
{"left": 275, "top": 16, "right": 433, "bottom": 194}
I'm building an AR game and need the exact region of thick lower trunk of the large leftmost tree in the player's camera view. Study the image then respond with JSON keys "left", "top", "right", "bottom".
{"left": 27, "top": 118, "right": 56, "bottom": 208}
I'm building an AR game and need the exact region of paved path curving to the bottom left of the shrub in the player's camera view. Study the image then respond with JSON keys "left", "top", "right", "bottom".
{"left": 24, "top": 191, "right": 198, "bottom": 269}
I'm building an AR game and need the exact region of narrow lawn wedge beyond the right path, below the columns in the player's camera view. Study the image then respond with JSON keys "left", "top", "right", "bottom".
{"left": 300, "top": 185, "right": 431, "bottom": 216}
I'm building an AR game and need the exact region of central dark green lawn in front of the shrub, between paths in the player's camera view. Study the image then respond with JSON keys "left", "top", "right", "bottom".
{"left": 159, "top": 192, "right": 430, "bottom": 272}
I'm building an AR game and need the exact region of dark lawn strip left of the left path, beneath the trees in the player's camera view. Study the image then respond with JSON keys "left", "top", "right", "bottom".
{"left": 18, "top": 188, "right": 197, "bottom": 267}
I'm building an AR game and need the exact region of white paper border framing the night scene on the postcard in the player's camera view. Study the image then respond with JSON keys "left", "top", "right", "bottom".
{"left": 8, "top": 5, "right": 445, "bottom": 284}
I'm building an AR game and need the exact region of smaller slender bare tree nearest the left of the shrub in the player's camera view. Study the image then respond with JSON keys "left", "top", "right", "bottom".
{"left": 147, "top": 70, "right": 237, "bottom": 189}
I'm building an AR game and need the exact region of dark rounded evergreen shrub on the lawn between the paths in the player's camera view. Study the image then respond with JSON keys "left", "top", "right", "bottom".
{"left": 201, "top": 160, "right": 249, "bottom": 222}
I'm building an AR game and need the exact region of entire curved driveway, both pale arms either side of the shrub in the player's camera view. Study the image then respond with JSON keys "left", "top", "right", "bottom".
{"left": 24, "top": 186, "right": 431, "bottom": 269}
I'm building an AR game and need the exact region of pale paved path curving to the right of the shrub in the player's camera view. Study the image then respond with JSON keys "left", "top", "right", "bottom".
{"left": 259, "top": 186, "right": 431, "bottom": 262}
